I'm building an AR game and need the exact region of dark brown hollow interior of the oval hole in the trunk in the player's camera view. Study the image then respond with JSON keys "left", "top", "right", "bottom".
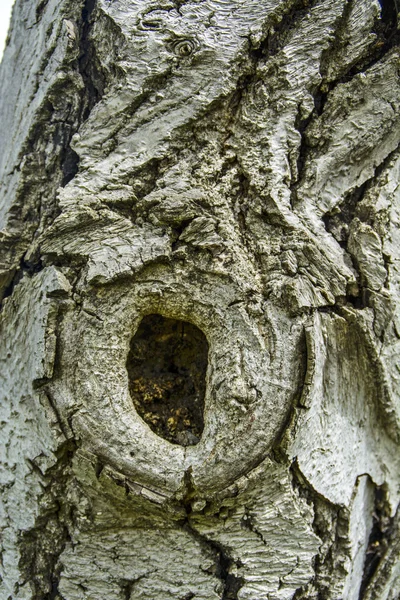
{"left": 127, "top": 314, "right": 208, "bottom": 446}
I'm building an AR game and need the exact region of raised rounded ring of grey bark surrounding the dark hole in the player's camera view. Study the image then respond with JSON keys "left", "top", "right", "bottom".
{"left": 53, "top": 273, "right": 303, "bottom": 496}
